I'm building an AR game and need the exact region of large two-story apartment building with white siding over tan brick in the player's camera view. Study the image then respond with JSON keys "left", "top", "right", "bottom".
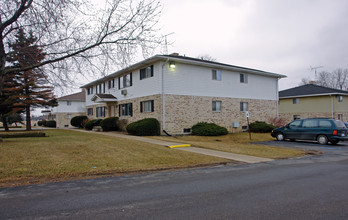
{"left": 82, "top": 54, "right": 285, "bottom": 134}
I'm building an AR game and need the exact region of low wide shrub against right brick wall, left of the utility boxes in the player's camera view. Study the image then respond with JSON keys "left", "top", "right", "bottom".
{"left": 192, "top": 122, "right": 228, "bottom": 136}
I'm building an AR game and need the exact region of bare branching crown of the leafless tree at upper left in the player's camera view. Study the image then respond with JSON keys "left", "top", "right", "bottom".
{"left": 0, "top": 0, "right": 161, "bottom": 92}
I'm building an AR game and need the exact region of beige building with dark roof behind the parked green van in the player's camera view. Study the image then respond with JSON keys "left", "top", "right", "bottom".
{"left": 279, "top": 84, "right": 348, "bottom": 121}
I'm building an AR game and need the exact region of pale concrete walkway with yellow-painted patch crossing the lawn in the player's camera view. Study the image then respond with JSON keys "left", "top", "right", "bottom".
{"left": 72, "top": 129, "right": 273, "bottom": 163}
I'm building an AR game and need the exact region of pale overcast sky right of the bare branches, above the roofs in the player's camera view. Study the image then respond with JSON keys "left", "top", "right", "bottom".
{"left": 156, "top": 0, "right": 348, "bottom": 90}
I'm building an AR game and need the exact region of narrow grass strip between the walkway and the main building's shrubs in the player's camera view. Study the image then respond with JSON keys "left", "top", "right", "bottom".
{"left": 152, "top": 133, "right": 306, "bottom": 159}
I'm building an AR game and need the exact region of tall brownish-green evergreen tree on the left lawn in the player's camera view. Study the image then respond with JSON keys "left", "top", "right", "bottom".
{"left": 8, "top": 29, "right": 57, "bottom": 130}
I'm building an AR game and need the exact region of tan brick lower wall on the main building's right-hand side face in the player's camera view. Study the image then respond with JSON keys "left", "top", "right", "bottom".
{"left": 165, "top": 95, "right": 277, "bottom": 134}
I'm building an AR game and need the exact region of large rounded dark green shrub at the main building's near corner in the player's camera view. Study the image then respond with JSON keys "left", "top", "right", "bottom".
{"left": 126, "top": 118, "right": 160, "bottom": 136}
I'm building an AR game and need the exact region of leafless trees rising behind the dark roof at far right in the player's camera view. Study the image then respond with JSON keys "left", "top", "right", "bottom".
{"left": 300, "top": 68, "right": 348, "bottom": 90}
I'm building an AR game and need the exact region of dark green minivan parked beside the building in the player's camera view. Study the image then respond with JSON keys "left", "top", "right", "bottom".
{"left": 271, "top": 118, "right": 348, "bottom": 144}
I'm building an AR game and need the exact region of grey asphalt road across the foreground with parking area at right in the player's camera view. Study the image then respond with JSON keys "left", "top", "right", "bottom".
{"left": 0, "top": 141, "right": 348, "bottom": 219}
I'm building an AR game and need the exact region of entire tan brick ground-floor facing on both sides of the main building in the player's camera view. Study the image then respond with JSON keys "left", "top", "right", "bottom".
{"left": 87, "top": 95, "right": 277, "bottom": 134}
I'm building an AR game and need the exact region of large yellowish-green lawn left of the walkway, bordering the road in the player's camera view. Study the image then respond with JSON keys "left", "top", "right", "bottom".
{"left": 0, "top": 130, "right": 231, "bottom": 187}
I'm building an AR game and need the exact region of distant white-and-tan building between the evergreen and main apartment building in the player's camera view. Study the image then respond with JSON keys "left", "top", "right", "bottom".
{"left": 42, "top": 91, "right": 86, "bottom": 128}
